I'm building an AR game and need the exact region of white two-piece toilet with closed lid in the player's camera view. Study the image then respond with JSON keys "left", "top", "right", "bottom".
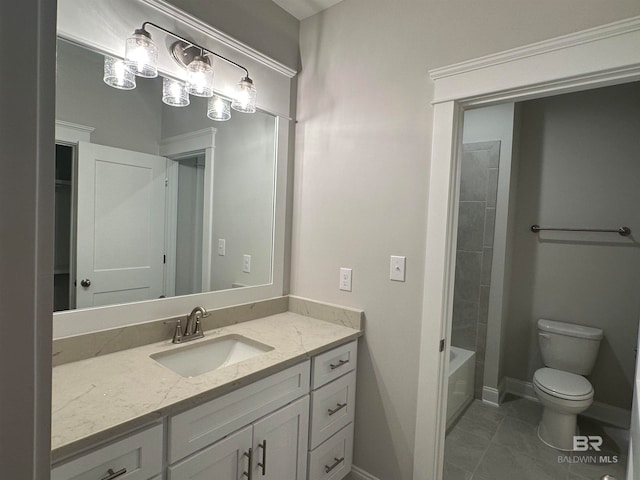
{"left": 533, "top": 319, "right": 603, "bottom": 450}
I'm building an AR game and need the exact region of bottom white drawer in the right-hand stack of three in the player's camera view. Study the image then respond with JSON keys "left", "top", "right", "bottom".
{"left": 308, "top": 423, "right": 353, "bottom": 480}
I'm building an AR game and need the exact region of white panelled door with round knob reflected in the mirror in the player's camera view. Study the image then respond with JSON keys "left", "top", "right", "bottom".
{"left": 76, "top": 142, "right": 166, "bottom": 308}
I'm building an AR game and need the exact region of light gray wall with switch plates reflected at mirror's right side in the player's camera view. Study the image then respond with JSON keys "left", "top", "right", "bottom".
{"left": 211, "top": 112, "right": 275, "bottom": 290}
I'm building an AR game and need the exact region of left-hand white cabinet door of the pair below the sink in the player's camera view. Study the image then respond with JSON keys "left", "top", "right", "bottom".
{"left": 168, "top": 426, "right": 255, "bottom": 480}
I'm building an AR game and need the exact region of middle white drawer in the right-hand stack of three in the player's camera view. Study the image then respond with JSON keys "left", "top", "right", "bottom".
{"left": 309, "top": 371, "right": 356, "bottom": 449}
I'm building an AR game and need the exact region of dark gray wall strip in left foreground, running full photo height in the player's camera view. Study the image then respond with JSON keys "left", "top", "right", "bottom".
{"left": 0, "top": 0, "right": 56, "bottom": 480}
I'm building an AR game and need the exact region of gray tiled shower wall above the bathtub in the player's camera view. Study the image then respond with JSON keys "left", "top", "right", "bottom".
{"left": 451, "top": 141, "right": 500, "bottom": 398}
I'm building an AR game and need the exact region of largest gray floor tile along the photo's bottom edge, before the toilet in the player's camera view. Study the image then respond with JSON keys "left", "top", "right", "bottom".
{"left": 472, "top": 444, "right": 567, "bottom": 480}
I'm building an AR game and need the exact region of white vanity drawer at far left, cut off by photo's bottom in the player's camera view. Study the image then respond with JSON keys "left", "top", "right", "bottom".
{"left": 51, "top": 425, "right": 162, "bottom": 480}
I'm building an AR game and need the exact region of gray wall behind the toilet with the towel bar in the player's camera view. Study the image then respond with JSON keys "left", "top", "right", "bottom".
{"left": 504, "top": 83, "right": 640, "bottom": 409}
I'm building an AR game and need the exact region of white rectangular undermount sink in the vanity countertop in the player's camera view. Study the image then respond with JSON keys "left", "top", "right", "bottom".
{"left": 151, "top": 335, "right": 273, "bottom": 377}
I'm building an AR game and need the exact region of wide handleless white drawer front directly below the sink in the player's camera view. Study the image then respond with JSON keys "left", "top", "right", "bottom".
{"left": 169, "top": 360, "right": 309, "bottom": 463}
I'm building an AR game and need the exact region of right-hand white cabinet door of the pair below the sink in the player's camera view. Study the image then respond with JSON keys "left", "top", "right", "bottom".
{"left": 252, "top": 396, "right": 309, "bottom": 480}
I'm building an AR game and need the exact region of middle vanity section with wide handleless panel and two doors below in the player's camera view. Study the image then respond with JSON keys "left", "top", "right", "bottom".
{"left": 167, "top": 361, "right": 310, "bottom": 480}
